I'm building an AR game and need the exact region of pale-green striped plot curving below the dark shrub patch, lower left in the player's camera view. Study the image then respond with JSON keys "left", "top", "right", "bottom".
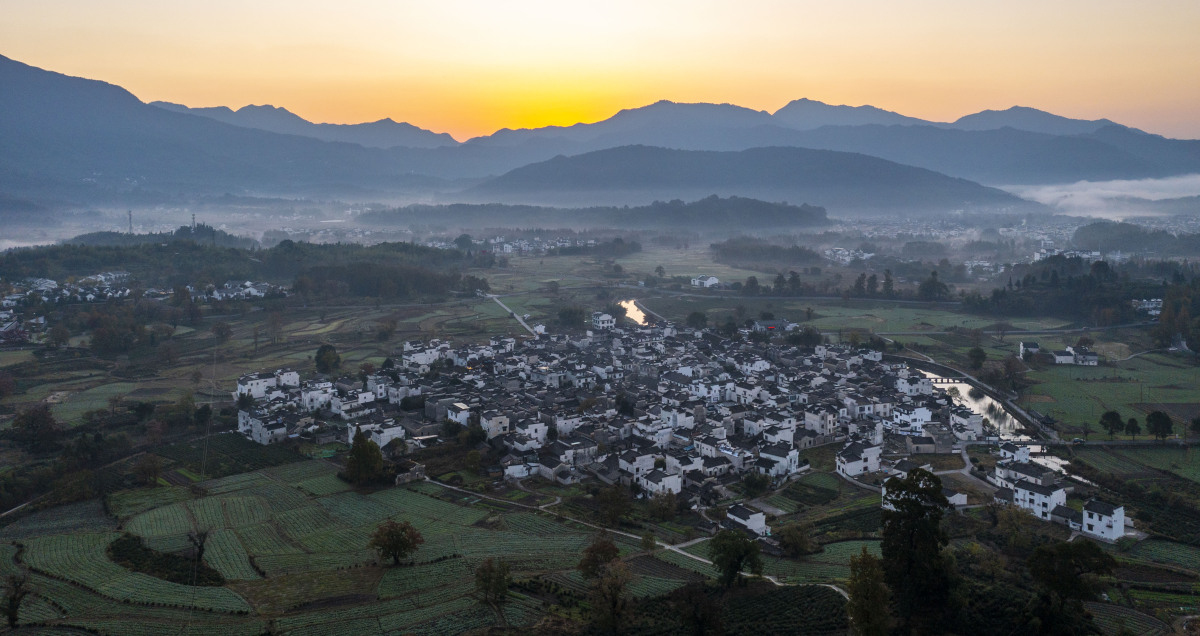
{"left": 24, "top": 533, "right": 250, "bottom": 613}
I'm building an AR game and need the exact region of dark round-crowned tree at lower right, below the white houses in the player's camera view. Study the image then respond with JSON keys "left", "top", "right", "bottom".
{"left": 1028, "top": 540, "right": 1117, "bottom": 607}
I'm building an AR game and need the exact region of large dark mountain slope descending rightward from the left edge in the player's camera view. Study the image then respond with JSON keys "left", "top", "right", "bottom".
{"left": 0, "top": 58, "right": 438, "bottom": 200}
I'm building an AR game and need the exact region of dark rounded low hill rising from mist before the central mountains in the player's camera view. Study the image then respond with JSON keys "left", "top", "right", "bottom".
{"left": 462, "top": 146, "right": 1033, "bottom": 214}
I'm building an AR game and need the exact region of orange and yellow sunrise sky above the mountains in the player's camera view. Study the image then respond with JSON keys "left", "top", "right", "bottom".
{"left": 0, "top": 0, "right": 1200, "bottom": 139}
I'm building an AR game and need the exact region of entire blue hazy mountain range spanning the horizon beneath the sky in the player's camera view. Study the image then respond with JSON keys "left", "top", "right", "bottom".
{"left": 0, "top": 51, "right": 1200, "bottom": 215}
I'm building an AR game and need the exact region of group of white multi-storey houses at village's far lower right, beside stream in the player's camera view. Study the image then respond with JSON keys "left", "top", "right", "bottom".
{"left": 988, "top": 443, "right": 1126, "bottom": 542}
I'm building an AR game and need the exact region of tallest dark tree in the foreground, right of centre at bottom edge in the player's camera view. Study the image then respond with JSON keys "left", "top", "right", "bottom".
{"left": 882, "top": 468, "right": 954, "bottom": 634}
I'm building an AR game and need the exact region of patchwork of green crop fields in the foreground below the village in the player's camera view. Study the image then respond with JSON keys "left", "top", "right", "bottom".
{"left": 0, "top": 453, "right": 857, "bottom": 635}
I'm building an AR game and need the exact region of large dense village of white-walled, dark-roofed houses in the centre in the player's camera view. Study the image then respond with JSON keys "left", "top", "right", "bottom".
{"left": 234, "top": 314, "right": 1008, "bottom": 535}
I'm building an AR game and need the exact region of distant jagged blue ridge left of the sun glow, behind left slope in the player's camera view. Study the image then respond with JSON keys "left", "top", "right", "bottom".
{"left": 150, "top": 102, "right": 458, "bottom": 148}
